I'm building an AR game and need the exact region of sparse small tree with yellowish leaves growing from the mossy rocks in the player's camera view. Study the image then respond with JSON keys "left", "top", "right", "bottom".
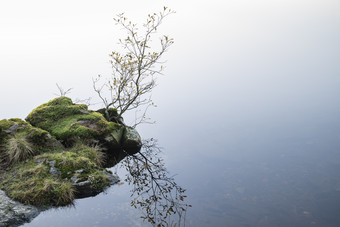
{"left": 93, "top": 7, "right": 174, "bottom": 124}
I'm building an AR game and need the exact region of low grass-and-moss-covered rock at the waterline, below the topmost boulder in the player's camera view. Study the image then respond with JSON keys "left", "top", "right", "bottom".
{"left": 0, "top": 145, "right": 117, "bottom": 206}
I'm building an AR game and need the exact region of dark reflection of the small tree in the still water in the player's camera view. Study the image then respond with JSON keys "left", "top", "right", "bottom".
{"left": 122, "top": 139, "right": 191, "bottom": 226}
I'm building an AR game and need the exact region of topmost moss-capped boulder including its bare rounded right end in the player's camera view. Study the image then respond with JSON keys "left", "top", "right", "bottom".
{"left": 26, "top": 97, "right": 142, "bottom": 154}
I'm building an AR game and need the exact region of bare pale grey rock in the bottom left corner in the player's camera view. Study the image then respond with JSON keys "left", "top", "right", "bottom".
{"left": 0, "top": 190, "right": 40, "bottom": 227}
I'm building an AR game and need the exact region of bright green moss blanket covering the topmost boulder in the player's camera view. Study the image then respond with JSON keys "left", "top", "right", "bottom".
{"left": 26, "top": 97, "right": 121, "bottom": 144}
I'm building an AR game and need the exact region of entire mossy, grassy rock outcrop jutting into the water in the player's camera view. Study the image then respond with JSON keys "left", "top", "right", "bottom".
{"left": 0, "top": 97, "right": 142, "bottom": 226}
